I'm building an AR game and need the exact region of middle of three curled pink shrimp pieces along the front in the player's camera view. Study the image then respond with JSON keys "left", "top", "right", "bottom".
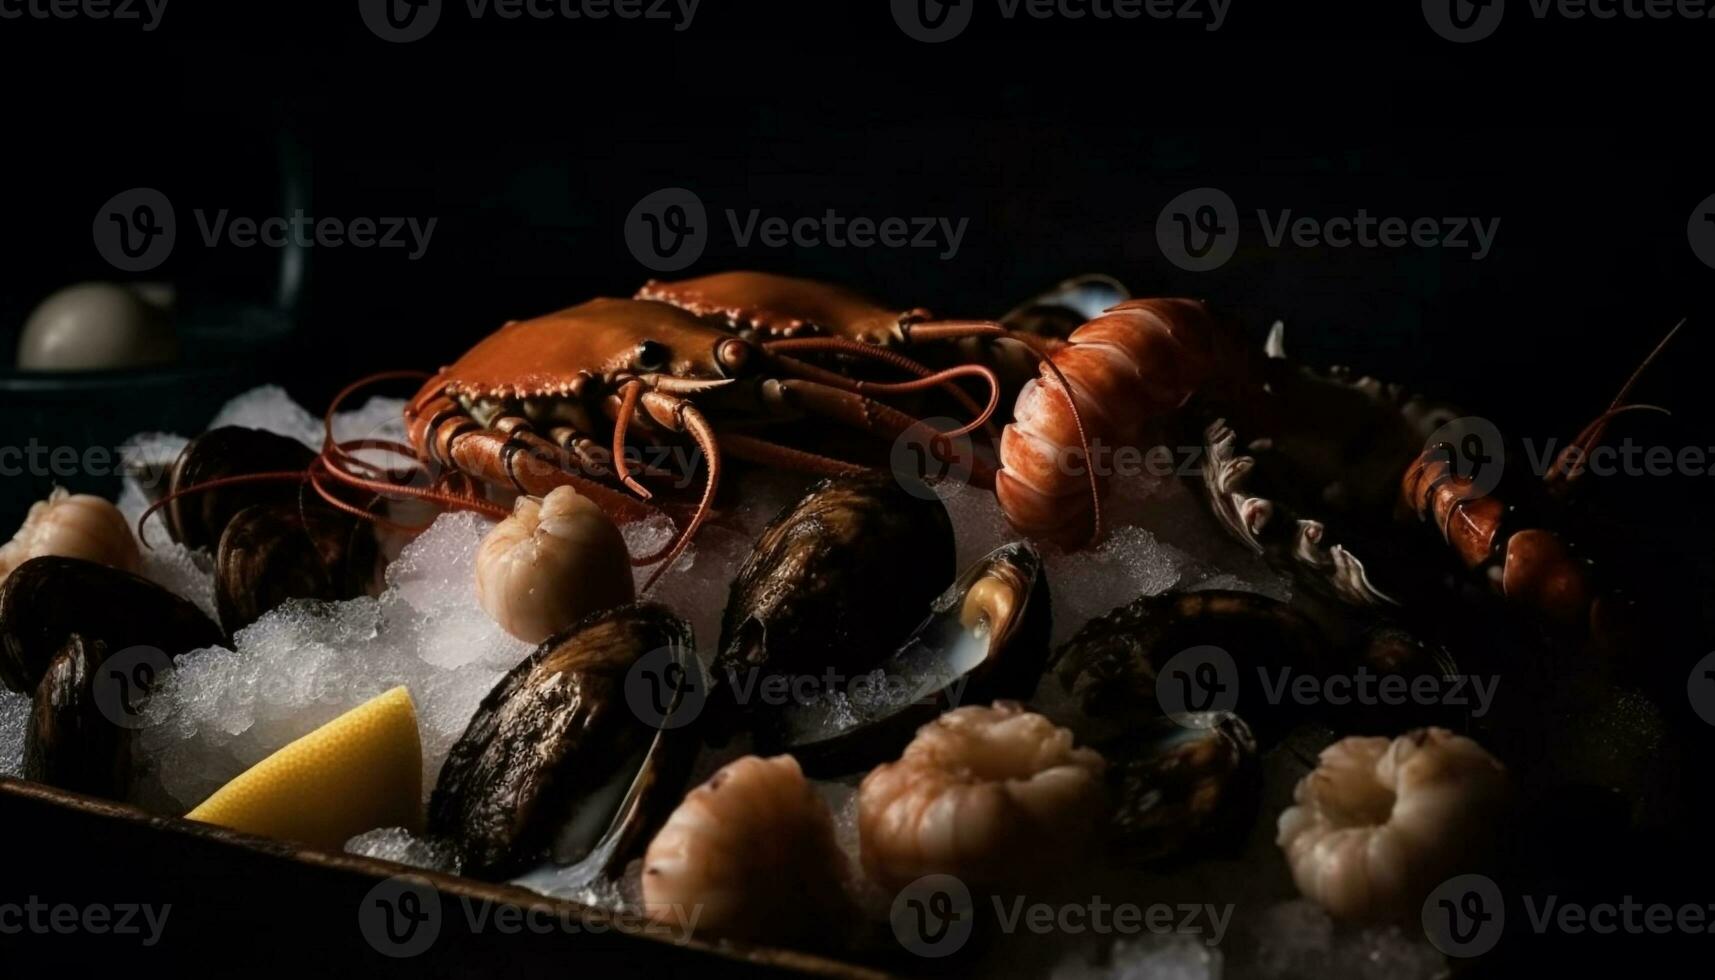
{"left": 858, "top": 702, "right": 1108, "bottom": 889}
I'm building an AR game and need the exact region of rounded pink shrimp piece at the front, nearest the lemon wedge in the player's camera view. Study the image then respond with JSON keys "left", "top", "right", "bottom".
{"left": 643, "top": 755, "right": 852, "bottom": 944}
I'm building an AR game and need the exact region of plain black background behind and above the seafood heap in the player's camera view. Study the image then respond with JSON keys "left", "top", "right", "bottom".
{"left": 0, "top": 0, "right": 1715, "bottom": 974}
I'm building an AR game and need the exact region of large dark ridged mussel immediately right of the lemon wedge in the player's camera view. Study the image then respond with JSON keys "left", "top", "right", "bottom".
{"left": 429, "top": 602, "right": 698, "bottom": 879}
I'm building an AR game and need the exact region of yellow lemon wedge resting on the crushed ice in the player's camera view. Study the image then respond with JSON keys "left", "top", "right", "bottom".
{"left": 185, "top": 687, "right": 424, "bottom": 850}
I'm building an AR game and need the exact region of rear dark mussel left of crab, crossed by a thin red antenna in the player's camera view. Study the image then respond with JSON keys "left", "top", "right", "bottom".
{"left": 165, "top": 426, "right": 316, "bottom": 549}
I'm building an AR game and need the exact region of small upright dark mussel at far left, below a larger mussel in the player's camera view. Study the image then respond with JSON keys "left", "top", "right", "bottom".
{"left": 24, "top": 635, "right": 130, "bottom": 800}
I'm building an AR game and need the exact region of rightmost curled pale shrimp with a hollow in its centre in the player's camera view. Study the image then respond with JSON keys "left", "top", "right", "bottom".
{"left": 1279, "top": 728, "right": 1507, "bottom": 918}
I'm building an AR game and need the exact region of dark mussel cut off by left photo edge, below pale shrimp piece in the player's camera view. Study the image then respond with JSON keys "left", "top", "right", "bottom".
{"left": 0, "top": 556, "right": 226, "bottom": 693}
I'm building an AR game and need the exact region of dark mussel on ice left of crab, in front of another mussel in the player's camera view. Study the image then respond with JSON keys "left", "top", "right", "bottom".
{"left": 214, "top": 501, "right": 376, "bottom": 632}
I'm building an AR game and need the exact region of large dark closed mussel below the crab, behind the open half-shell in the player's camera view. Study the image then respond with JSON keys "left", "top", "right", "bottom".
{"left": 710, "top": 474, "right": 957, "bottom": 713}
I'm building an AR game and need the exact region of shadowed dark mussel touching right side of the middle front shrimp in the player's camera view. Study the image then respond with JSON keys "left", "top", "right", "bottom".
{"left": 1092, "top": 711, "right": 1261, "bottom": 860}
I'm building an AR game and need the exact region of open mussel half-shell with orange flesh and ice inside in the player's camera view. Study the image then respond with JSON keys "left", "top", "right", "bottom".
{"left": 756, "top": 542, "right": 1051, "bottom": 776}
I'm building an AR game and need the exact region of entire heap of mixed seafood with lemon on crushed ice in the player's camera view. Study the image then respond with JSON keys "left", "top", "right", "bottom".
{"left": 0, "top": 271, "right": 1693, "bottom": 980}
